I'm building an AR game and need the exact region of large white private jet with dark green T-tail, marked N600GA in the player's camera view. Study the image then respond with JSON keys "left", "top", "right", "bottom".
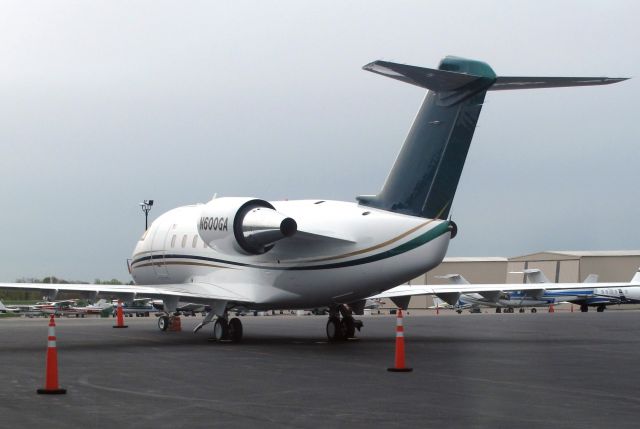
{"left": 0, "top": 57, "right": 624, "bottom": 341}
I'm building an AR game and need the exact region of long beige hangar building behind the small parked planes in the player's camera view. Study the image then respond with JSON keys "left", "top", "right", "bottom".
{"left": 382, "top": 250, "right": 640, "bottom": 309}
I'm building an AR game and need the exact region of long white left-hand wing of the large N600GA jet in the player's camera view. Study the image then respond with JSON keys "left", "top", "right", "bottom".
{"left": 0, "top": 282, "right": 252, "bottom": 303}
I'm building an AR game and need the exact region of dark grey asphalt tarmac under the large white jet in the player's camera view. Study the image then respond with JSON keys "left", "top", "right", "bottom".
{"left": 0, "top": 311, "right": 640, "bottom": 428}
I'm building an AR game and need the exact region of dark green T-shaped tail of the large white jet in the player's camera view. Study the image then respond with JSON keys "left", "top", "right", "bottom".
{"left": 358, "top": 57, "right": 625, "bottom": 219}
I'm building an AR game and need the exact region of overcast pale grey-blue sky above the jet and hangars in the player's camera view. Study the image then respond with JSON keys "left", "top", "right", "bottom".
{"left": 0, "top": 0, "right": 640, "bottom": 281}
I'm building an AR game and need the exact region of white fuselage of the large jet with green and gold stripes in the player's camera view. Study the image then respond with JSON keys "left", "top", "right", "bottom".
{"left": 131, "top": 199, "right": 451, "bottom": 309}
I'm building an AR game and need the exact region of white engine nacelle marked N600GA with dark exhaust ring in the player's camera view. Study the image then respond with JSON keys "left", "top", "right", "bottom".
{"left": 198, "top": 198, "right": 298, "bottom": 255}
